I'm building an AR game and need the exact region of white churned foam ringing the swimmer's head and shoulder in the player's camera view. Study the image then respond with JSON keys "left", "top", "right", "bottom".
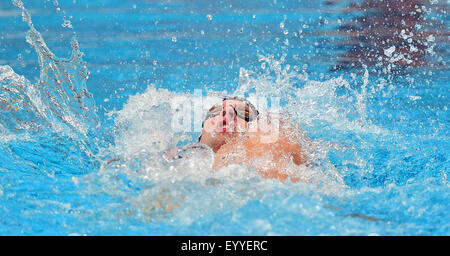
{"left": 79, "top": 52, "right": 396, "bottom": 225}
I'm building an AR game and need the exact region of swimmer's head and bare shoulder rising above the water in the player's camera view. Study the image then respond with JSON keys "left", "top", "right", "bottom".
{"left": 199, "top": 97, "right": 308, "bottom": 182}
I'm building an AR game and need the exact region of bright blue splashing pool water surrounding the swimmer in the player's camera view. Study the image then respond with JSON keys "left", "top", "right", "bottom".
{"left": 0, "top": 0, "right": 450, "bottom": 235}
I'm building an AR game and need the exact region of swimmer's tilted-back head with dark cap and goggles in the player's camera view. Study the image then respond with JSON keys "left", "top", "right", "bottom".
{"left": 199, "top": 97, "right": 259, "bottom": 152}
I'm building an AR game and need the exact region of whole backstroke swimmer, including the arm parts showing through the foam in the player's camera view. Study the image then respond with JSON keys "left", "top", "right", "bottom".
{"left": 114, "top": 97, "right": 310, "bottom": 221}
